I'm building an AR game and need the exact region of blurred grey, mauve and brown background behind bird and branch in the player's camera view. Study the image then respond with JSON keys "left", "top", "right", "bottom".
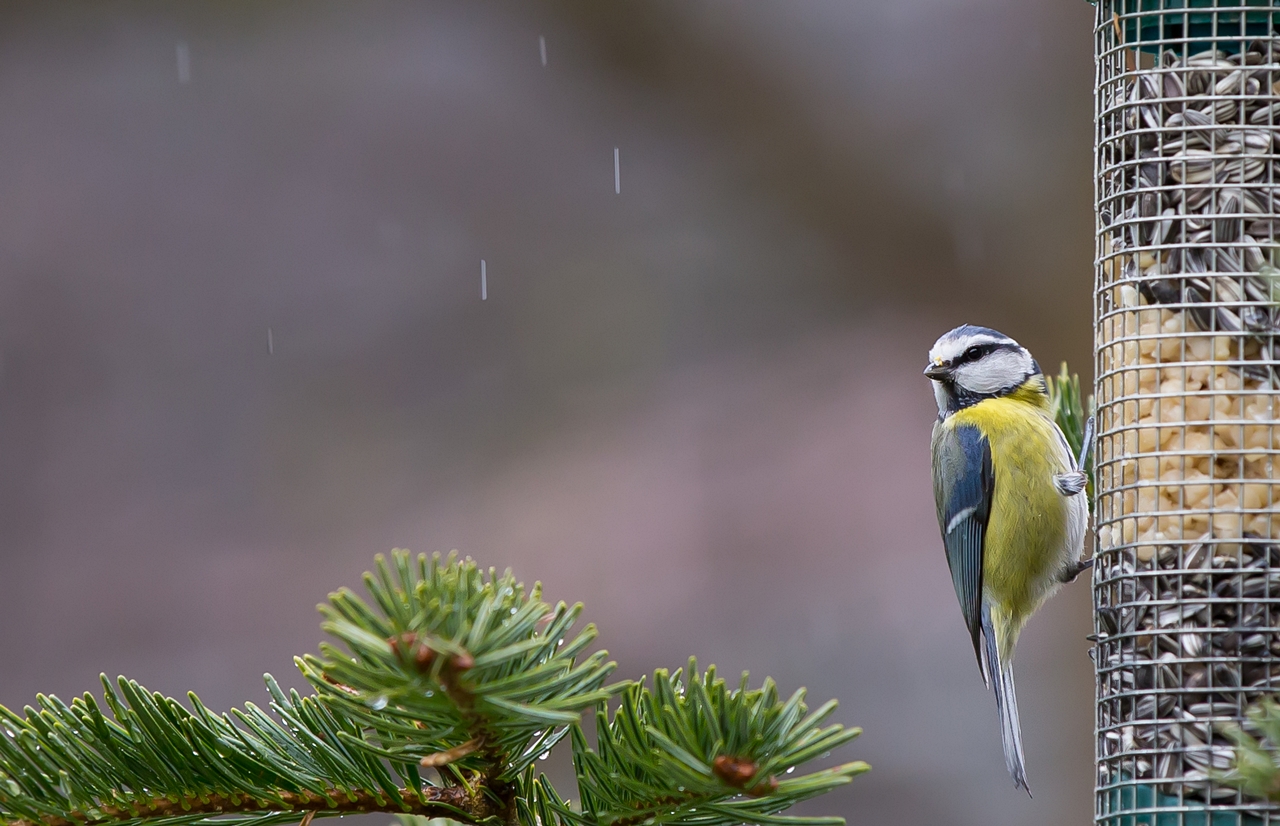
{"left": 0, "top": 0, "right": 1093, "bottom": 826}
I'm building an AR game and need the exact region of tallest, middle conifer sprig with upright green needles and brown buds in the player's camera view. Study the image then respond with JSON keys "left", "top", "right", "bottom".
{"left": 298, "top": 553, "right": 623, "bottom": 782}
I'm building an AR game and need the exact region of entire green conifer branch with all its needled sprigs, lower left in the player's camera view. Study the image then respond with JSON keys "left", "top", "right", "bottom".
{"left": 0, "top": 552, "right": 867, "bottom": 826}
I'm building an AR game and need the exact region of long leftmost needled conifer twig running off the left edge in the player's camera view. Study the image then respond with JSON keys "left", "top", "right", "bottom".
{"left": 0, "top": 676, "right": 509, "bottom": 826}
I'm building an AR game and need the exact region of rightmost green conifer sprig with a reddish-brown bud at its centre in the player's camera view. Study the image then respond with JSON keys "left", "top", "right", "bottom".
{"left": 521, "top": 660, "right": 870, "bottom": 826}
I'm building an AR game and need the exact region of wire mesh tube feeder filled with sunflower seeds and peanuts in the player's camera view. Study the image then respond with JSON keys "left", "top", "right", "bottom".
{"left": 1093, "top": 0, "right": 1280, "bottom": 826}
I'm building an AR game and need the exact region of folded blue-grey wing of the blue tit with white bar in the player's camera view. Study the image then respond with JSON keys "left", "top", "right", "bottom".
{"left": 933, "top": 421, "right": 996, "bottom": 667}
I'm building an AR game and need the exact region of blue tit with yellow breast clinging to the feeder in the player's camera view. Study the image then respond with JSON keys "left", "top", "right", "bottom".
{"left": 924, "top": 324, "right": 1092, "bottom": 794}
